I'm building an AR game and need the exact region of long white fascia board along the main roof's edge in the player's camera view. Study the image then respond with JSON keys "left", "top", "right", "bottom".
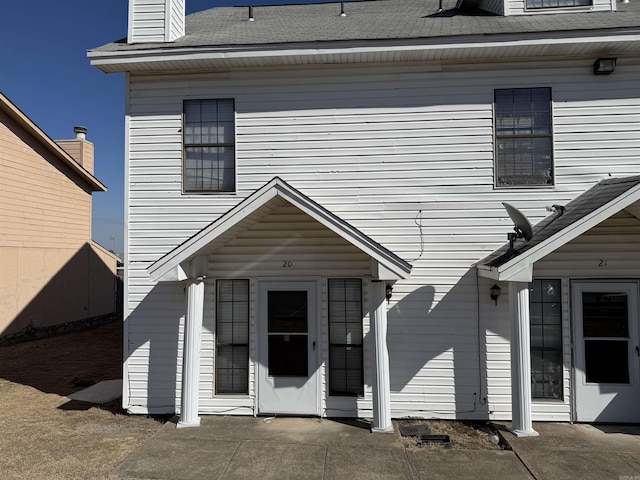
{"left": 87, "top": 32, "right": 640, "bottom": 71}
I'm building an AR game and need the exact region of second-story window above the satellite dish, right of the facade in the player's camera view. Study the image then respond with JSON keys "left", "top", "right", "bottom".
{"left": 495, "top": 88, "right": 553, "bottom": 187}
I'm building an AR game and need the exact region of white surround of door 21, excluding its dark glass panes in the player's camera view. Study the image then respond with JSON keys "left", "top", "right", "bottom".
{"left": 571, "top": 279, "right": 640, "bottom": 422}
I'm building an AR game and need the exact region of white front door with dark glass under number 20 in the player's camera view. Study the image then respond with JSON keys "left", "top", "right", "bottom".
{"left": 258, "top": 281, "right": 319, "bottom": 415}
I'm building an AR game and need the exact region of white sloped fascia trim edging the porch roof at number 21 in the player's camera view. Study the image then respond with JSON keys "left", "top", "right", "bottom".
{"left": 476, "top": 180, "right": 640, "bottom": 282}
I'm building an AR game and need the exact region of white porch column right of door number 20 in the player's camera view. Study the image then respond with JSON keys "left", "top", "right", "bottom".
{"left": 371, "top": 282, "right": 393, "bottom": 433}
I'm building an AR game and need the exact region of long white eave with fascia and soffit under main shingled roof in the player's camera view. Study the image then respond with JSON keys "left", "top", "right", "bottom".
{"left": 88, "top": 32, "right": 640, "bottom": 73}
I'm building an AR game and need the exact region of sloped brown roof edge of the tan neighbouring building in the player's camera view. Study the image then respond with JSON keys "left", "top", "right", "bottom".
{"left": 0, "top": 92, "right": 107, "bottom": 192}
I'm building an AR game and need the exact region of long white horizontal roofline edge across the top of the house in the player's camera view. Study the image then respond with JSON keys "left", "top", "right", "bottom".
{"left": 87, "top": 28, "right": 640, "bottom": 73}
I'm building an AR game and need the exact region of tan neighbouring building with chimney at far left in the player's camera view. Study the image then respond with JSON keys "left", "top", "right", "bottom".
{"left": 0, "top": 93, "right": 118, "bottom": 336}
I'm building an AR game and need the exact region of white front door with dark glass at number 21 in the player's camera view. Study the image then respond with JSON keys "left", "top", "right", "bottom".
{"left": 572, "top": 281, "right": 640, "bottom": 422}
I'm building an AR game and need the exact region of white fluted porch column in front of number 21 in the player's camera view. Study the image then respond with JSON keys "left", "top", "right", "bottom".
{"left": 508, "top": 282, "right": 538, "bottom": 437}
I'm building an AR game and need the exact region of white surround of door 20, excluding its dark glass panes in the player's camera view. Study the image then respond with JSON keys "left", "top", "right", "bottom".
{"left": 256, "top": 279, "right": 321, "bottom": 416}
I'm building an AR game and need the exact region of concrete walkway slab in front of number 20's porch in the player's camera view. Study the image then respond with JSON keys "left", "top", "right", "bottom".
{"left": 115, "top": 416, "right": 531, "bottom": 480}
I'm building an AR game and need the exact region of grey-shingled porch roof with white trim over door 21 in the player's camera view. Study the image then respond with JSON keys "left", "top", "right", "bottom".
{"left": 476, "top": 176, "right": 640, "bottom": 282}
